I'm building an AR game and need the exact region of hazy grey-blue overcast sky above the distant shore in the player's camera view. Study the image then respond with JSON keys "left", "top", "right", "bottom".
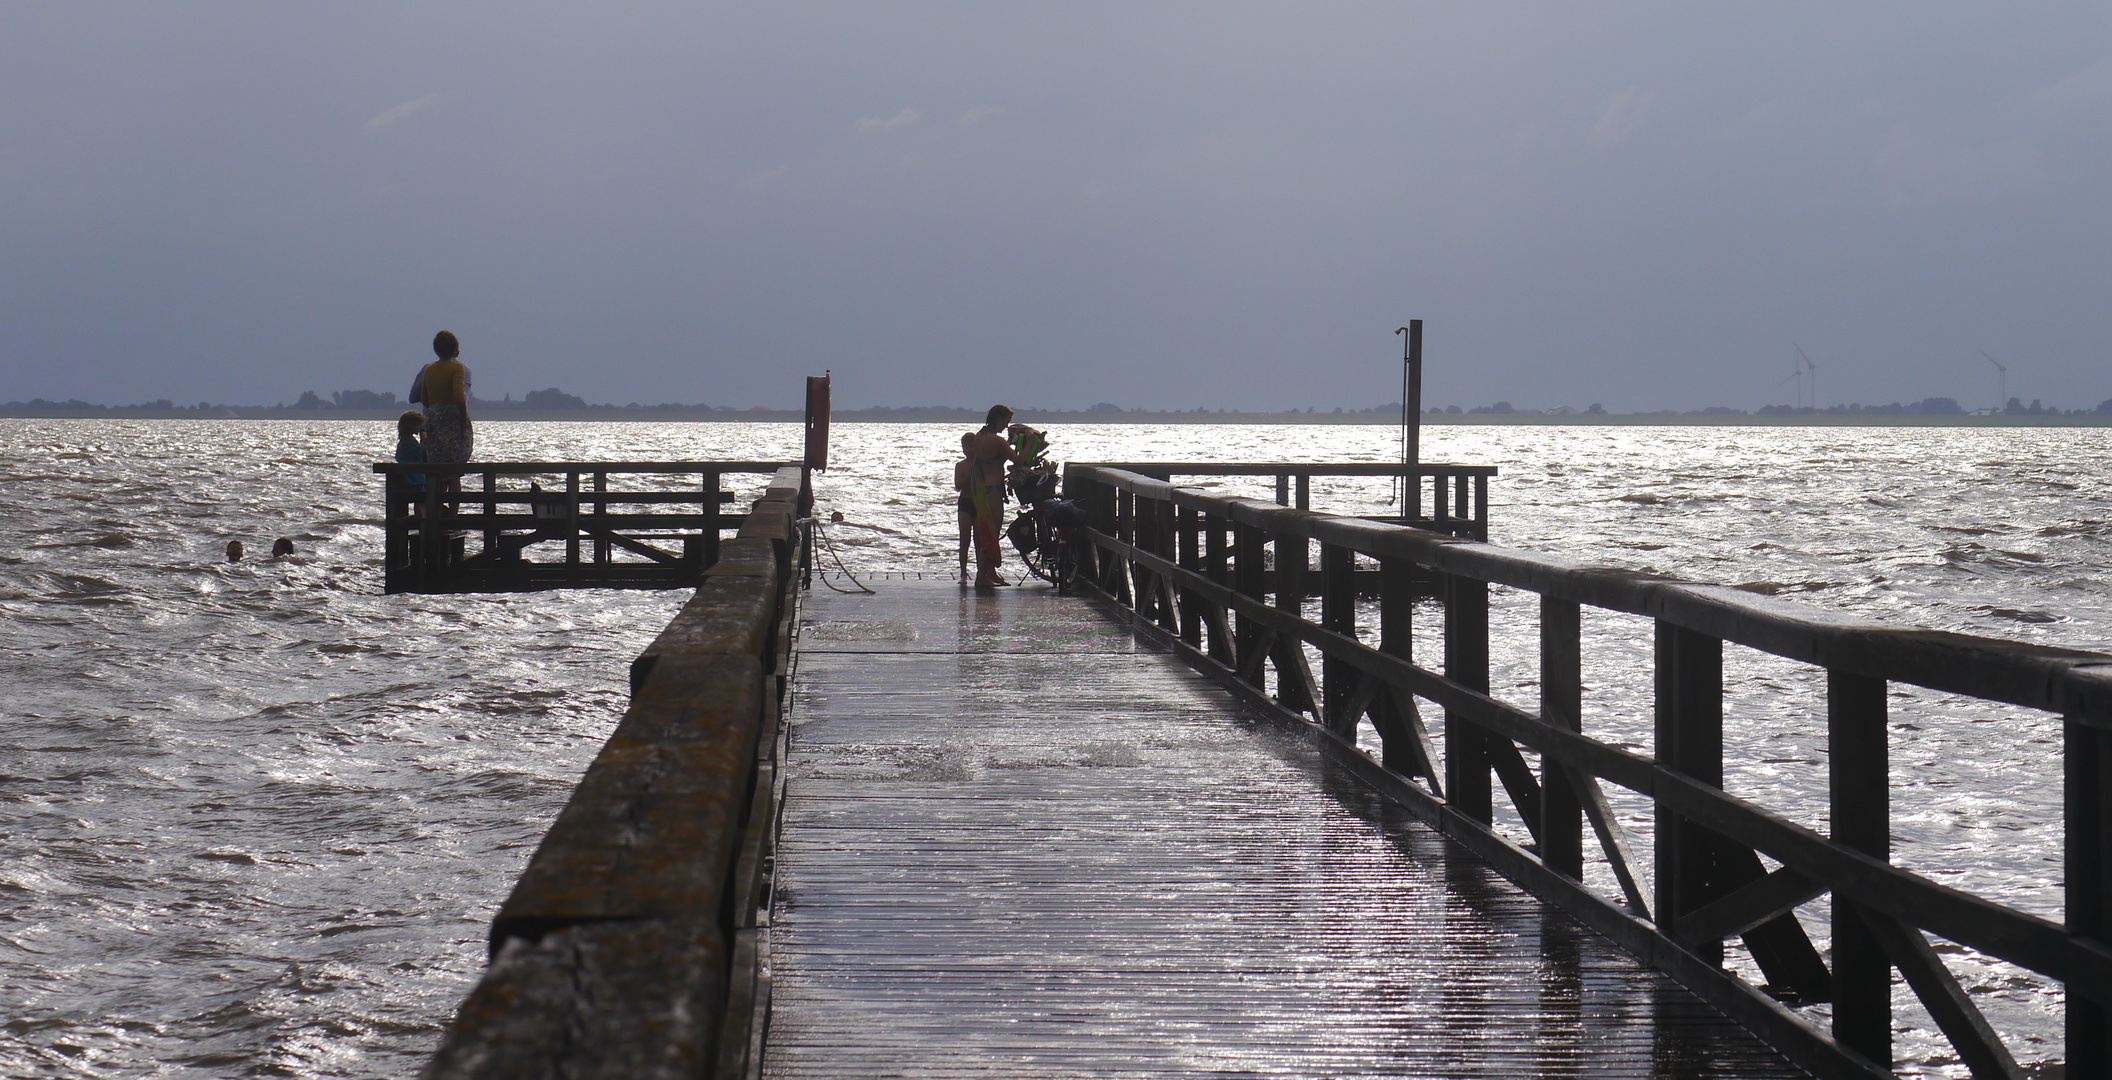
{"left": 0, "top": 0, "right": 2112, "bottom": 412}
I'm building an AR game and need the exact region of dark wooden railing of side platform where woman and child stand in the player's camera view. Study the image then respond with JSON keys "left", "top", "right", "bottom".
{"left": 374, "top": 461, "right": 792, "bottom": 592}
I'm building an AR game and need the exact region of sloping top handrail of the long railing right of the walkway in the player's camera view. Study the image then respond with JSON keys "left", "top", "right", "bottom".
{"left": 1073, "top": 465, "right": 2112, "bottom": 727}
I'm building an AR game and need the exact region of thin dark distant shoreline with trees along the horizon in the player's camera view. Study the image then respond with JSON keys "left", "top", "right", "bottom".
{"left": 0, "top": 404, "right": 2112, "bottom": 427}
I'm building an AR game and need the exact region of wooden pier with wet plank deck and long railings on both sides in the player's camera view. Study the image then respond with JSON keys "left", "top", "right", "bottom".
{"left": 427, "top": 463, "right": 2112, "bottom": 1080}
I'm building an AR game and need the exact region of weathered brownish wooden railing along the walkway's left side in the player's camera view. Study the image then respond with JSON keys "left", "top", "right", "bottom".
{"left": 425, "top": 467, "right": 803, "bottom": 1080}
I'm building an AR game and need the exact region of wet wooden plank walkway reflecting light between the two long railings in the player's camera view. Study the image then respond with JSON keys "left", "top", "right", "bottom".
{"left": 762, "top": 581, "right": 1799, "bottom": 1078}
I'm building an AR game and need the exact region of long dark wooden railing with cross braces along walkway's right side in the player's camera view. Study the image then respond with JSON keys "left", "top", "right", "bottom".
{"left": 1067, "top": 465, "right": 2112, "bottom": 1078}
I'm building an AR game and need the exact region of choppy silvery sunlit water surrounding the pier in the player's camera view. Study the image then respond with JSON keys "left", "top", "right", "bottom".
{"left": 0, "top": 421, "right": 2112, "bottom": 1076}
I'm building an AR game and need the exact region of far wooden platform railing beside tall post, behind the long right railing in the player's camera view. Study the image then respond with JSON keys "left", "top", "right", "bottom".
{"left": 1094, "top": 461, "right": 1495, "bottom": 539}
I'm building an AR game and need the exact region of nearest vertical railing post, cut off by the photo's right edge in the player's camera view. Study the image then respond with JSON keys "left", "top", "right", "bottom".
{"left": 2061, "top": 716, "right": 2112, "bottom": 1080}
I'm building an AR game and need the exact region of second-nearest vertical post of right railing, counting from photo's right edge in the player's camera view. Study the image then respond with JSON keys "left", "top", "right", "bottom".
{"left": 1827, "top": 670, "right": 1892, "bottom": 1065}
